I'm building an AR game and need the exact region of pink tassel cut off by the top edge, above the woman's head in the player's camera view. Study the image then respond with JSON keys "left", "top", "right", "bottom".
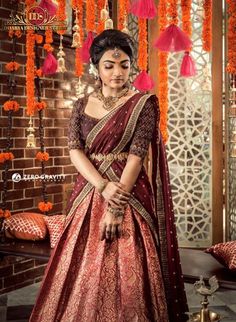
{"left": 130, "top": 0, "right": 157, "bottom": 19}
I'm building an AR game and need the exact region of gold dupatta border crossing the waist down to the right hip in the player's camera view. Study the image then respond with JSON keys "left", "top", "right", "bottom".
{"left": 106, "top": 168, "right": 159, "bottom": 246}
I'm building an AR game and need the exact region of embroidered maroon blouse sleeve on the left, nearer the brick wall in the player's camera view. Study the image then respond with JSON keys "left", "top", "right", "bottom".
{"left": 68, "top": 99, "right": 84, "bottom": 150}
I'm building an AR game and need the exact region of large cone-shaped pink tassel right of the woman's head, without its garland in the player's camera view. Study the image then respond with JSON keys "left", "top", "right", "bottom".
{"left": 154, "top": 24, "right": 192, "bottom": 52}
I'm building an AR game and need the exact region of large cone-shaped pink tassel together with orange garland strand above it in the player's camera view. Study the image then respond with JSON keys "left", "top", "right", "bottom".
{"left": 154, "top": 0, "right": 192, "bottom": 52}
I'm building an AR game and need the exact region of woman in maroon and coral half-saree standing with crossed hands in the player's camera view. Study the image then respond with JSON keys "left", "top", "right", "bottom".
{"left": 30, "top": 30, "right": 187, "bottom": 322}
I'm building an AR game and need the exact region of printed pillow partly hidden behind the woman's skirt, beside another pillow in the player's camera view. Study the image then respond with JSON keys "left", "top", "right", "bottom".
{"left": 44, "top": 215, "right": 66, "bottom": 248}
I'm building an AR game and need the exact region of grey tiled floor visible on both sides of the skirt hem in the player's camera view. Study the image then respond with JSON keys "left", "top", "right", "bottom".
{"left": 0, "top": 283, "right": 236, "bottom": 322}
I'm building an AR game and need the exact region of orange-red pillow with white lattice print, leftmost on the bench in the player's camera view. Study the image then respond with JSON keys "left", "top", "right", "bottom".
{"left": 4, "top": 212, "right": 47, "bottom": 240}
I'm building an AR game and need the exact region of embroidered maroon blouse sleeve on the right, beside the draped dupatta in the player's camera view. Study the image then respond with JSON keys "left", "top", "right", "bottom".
{"left": 129, "top": 95, "right": 159, "bottom": 159}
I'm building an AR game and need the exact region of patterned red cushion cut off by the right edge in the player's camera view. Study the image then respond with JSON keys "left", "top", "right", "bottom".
{"left": 206, "top": 240, "right": 236, "bottom": 271}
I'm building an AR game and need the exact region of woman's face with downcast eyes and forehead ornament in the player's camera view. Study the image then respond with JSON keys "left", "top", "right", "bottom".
{"left": 98, "top": 49, "right": 130, "bottom": 89}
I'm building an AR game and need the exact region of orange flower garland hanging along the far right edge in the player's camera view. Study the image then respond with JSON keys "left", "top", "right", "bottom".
{"left": 226, "top": 0, "right": 236, "bottom": 74}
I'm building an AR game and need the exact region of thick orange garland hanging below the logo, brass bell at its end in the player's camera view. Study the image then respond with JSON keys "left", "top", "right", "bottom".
{"left": 26, "top": 30, "right": 35, "bottom": 116}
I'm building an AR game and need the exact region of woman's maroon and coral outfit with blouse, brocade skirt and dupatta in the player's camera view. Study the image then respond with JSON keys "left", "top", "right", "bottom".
{"left": 30, "top": 93, "right": 188, "bottom": 322}
